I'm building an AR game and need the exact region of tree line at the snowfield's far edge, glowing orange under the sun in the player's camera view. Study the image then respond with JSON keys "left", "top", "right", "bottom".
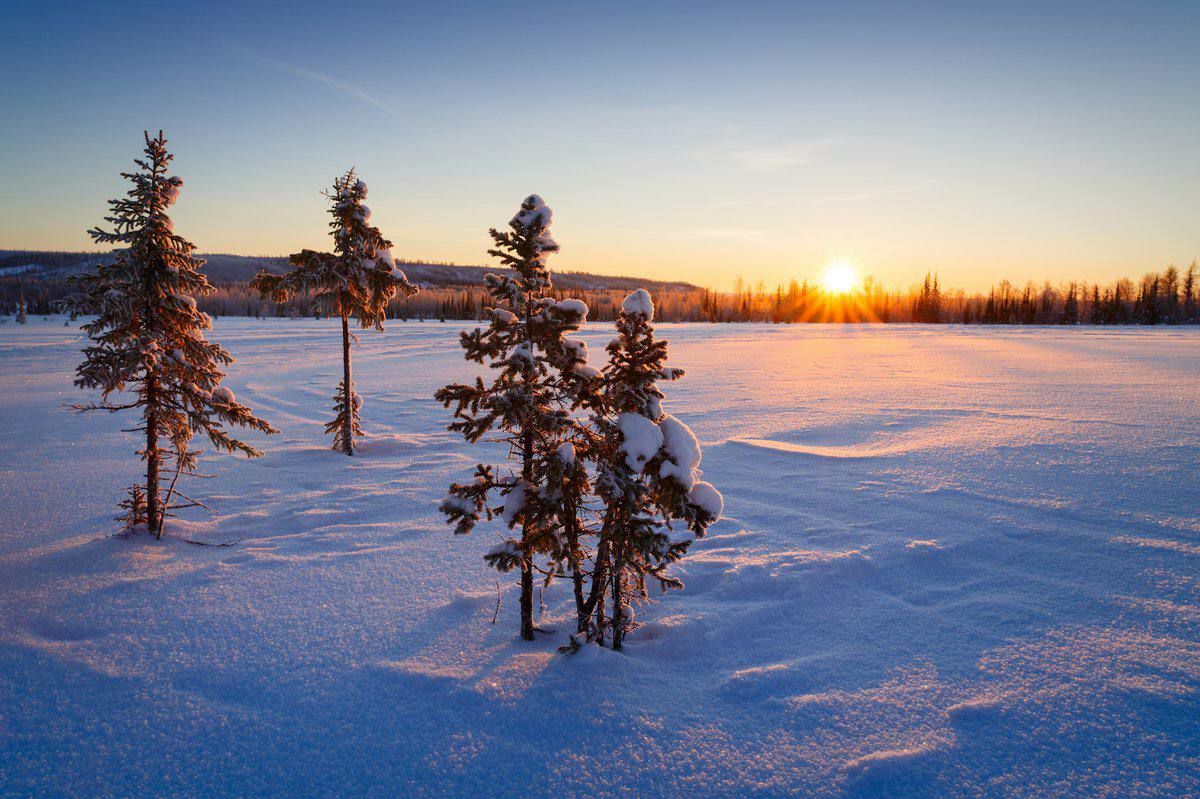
{"left": 0, "top": 258, "right": 1200, "bottom": 325}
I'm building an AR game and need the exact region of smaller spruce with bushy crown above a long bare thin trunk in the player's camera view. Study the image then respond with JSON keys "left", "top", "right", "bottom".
{"left": 251, "top": 169, "right": 416, "bottom": 455}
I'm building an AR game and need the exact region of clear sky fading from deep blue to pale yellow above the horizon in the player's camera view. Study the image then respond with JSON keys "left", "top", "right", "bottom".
{"left": 0, "top": 0, "right": 1200, "bottom": 290}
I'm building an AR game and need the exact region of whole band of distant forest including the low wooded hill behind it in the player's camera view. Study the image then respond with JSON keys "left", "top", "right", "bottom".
{"left": 0, "top": 253, "right": 1200, "bottom": 325}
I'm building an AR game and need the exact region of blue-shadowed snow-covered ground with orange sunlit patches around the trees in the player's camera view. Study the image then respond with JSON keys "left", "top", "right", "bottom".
{"left": 0, "top": 318, "right": 1200, "bottom": 798}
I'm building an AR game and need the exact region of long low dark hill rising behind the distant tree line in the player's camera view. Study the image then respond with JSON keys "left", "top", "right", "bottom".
{"left": 0, "top": 250, "right": 696, "bottom": 292}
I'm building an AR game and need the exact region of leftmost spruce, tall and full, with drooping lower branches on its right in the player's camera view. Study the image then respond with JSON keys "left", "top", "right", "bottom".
{"left": 66, "top": 131, "right": 276, "bottom": 537}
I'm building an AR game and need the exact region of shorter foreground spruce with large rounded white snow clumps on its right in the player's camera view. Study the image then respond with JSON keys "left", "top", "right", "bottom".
{"left": 593, "top": 289, "right": 724, "bottom": 649}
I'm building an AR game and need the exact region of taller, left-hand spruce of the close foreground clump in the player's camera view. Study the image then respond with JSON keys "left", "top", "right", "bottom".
{"left": 437, "top": 194, "right": 599, "bottom": 641}
